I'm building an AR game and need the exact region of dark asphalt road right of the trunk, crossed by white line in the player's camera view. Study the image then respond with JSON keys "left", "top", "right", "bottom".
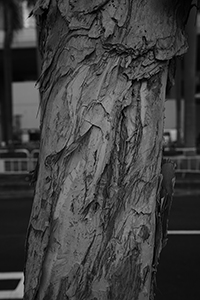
{"left": 155, "top": 193, "right": 200, "bottom": 300}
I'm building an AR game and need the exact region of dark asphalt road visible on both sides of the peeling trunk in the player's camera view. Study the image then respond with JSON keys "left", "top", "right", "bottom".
{"left": 0, "top": 186, "right": 200, "bottom": 300}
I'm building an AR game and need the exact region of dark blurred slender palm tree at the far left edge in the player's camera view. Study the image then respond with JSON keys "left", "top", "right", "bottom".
{"left": 0, "top": 0, "right": 22, "bottom": 144}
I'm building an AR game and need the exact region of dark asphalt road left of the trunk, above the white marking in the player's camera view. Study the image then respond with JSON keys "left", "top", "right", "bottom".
{"left": 0, "top": 197, "right": 32, "bottom": 272}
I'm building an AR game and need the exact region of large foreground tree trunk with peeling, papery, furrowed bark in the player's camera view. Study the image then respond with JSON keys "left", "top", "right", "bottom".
{"left": 24, "top": 0, "right": 194, "bottom": 300}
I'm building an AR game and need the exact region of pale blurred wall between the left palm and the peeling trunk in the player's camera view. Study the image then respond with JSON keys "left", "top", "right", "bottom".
{"left": 12, "top": 81, "right": 40, "bottom": 129}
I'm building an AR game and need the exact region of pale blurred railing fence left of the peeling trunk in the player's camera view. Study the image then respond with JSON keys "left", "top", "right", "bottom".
{"left": 0, "top": 149, "right": 39, "bottom": 174}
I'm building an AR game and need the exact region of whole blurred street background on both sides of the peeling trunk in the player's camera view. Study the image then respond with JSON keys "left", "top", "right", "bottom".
{"left": 0, "top": 0, "right": 200, "bottom": 300}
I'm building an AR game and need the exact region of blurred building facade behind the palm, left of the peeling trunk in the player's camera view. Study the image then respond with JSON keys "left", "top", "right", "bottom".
{"left": 0, "top": 2, "right": 40, "bottom": 142}
